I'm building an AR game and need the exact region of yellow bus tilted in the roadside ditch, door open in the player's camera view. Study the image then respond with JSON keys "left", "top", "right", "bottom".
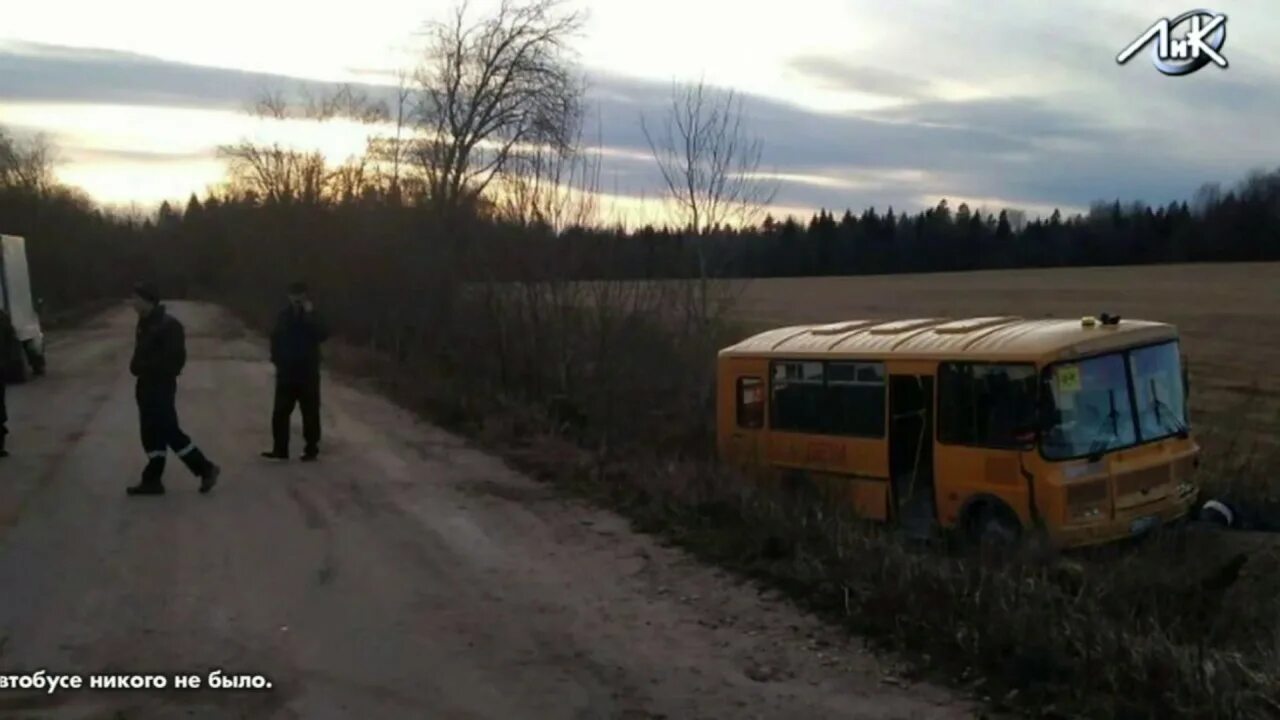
{"left": 717, "top": 314, "right": 1199, "bottom": 548}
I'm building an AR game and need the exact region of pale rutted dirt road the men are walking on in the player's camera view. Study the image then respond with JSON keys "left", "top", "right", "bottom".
{"left": 0, "top": 304, "right": 973, "bottom": 720}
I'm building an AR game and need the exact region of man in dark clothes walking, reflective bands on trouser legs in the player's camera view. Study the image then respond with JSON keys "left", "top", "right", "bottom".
{"left": 128, "top": 283, "right": 220, "bottom": 495}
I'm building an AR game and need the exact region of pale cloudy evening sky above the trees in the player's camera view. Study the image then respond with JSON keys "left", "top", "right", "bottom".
{"left": 0, "top": 0, "right": 1280, "bottom": 220}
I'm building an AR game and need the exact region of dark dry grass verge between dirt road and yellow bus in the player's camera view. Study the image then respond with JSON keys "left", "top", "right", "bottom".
{"left": 483, "top": 419, "right": 1280, "bottom": 720}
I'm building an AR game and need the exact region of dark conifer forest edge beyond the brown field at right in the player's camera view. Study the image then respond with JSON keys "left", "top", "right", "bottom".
{"left": 524, "top": 170, "right": 1280, "bottom": 278}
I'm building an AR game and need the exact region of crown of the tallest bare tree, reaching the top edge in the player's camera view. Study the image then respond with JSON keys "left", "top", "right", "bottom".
{"left": 415, "top": 0, "right": 582, "bottom": 221}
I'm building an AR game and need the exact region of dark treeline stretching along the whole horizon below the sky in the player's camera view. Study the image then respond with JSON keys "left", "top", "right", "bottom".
{"left": 0, "top": 120, "right": 1280, "bottom": 309}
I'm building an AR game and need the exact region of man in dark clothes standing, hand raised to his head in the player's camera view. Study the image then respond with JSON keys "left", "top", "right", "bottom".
{"left": 262, "top": 282, "right": 329, "bottom": 461}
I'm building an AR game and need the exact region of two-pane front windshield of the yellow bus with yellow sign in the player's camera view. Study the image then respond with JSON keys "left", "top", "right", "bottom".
{"left": 1041, "top": 341, "right": 1187, "bottom": 460}
